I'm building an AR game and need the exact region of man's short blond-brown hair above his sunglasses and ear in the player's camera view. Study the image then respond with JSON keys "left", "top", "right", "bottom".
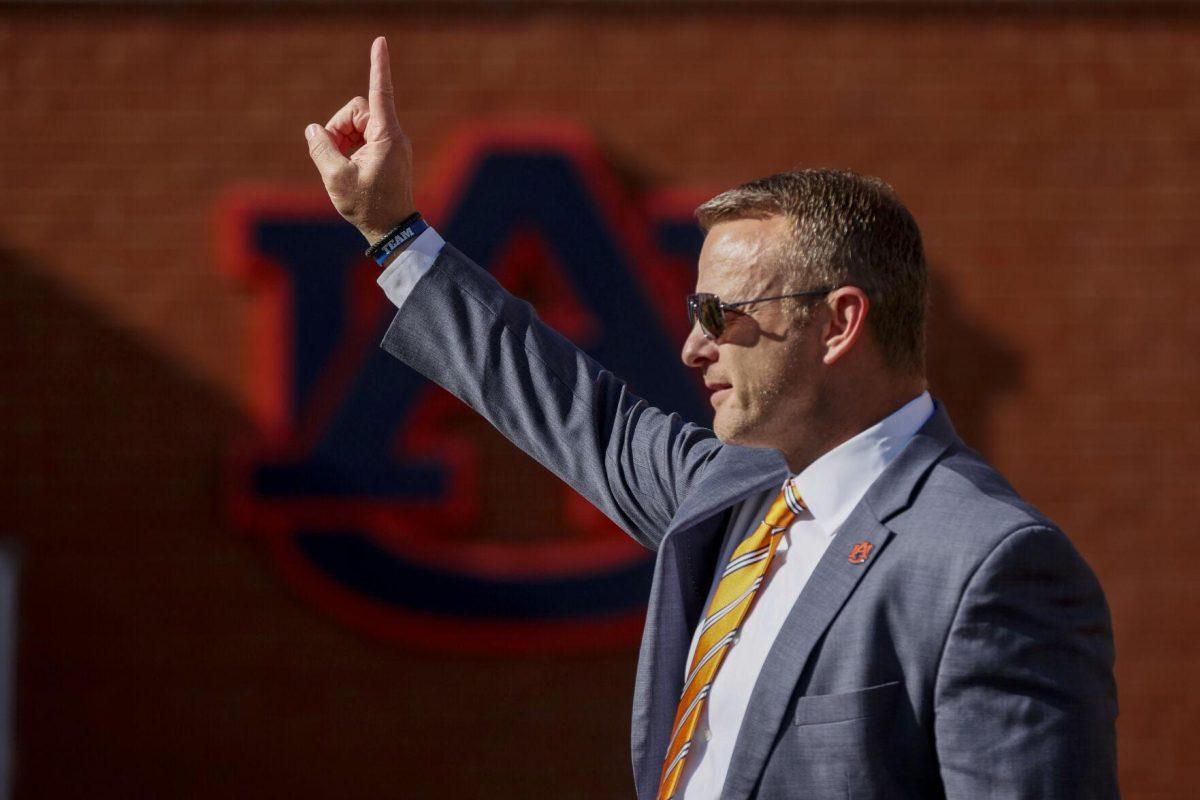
{"left": 696, "top": 169, "right": 929, "bottom": 374}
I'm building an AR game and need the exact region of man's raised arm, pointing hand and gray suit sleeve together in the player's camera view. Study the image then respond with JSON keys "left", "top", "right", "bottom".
{"left": 305, "top": 37, "right": 721, "bottom": 548}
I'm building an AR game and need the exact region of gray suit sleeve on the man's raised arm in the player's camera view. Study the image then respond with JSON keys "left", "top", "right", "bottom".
{"left": 382, "top": 245, "right": 721, "bottom": 549}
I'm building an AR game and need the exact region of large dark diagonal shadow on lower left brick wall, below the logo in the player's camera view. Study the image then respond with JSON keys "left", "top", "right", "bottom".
{"left": 0, "top": 246, "right": 636, "bottom": 800}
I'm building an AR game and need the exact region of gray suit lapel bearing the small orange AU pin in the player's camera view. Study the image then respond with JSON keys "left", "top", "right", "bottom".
{"left": 721, "top": 404, "right": 955, "bottom": 800}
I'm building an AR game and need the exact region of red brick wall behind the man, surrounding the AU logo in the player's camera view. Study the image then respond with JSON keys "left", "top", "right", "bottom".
{"left": 0, "top": 4, "right": 1200, "bottom": 798}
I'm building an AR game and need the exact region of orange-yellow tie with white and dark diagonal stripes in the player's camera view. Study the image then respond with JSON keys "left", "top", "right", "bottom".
{"left": 658, "top": 481, "right": 804, "bottom": 800}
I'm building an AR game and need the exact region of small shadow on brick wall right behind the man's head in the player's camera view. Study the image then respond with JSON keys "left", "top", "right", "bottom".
{"left": 928, "top": 270, "right": 1025, "bottom": 456}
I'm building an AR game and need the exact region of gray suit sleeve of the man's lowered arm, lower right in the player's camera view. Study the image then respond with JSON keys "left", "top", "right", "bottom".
{"left": 934, "top": 525, "right": 1120, "bottom": 800}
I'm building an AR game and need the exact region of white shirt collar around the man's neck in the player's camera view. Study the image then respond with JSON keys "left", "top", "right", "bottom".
{"left": 792, "top": 391, "right": 934, "bottom": 536}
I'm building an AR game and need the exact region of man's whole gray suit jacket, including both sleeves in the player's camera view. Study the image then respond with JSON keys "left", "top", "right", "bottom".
{"left": 383, "top": 245, "right": 1117, "bottom": 800}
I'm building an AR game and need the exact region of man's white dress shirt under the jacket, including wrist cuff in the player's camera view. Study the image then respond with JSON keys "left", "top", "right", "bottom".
{"left": 378, "top": 228, "right": 934, "bottom": 800}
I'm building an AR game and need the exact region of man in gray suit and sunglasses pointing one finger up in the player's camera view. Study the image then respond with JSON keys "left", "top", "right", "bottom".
{"left": 306, "top": 38, "right": 1117, "bottom": 800}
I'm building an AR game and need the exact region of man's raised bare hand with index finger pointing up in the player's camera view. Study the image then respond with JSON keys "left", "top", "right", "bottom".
{"left": 305, "top": 36, "right": 414, "bottom": 242}
